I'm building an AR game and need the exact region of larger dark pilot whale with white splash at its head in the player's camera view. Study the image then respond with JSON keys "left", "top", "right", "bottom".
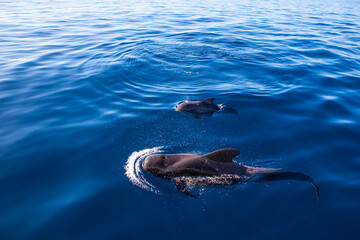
{"left": 142, "top": 148, "right": 320, "bottom": 206}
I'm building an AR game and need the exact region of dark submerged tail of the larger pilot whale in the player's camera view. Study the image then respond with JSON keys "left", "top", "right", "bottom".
{"left": 255, "top": 170, "right": 320, "bottom": 207}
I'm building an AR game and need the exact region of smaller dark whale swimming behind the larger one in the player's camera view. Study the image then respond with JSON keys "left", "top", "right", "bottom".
{"left": 176, "top": 98, "right": 239, "bottom": 118}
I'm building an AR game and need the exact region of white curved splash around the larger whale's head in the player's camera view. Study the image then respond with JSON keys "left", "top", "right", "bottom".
{"left": 125, "top": 147, "right": 163, "bottom": 193}
